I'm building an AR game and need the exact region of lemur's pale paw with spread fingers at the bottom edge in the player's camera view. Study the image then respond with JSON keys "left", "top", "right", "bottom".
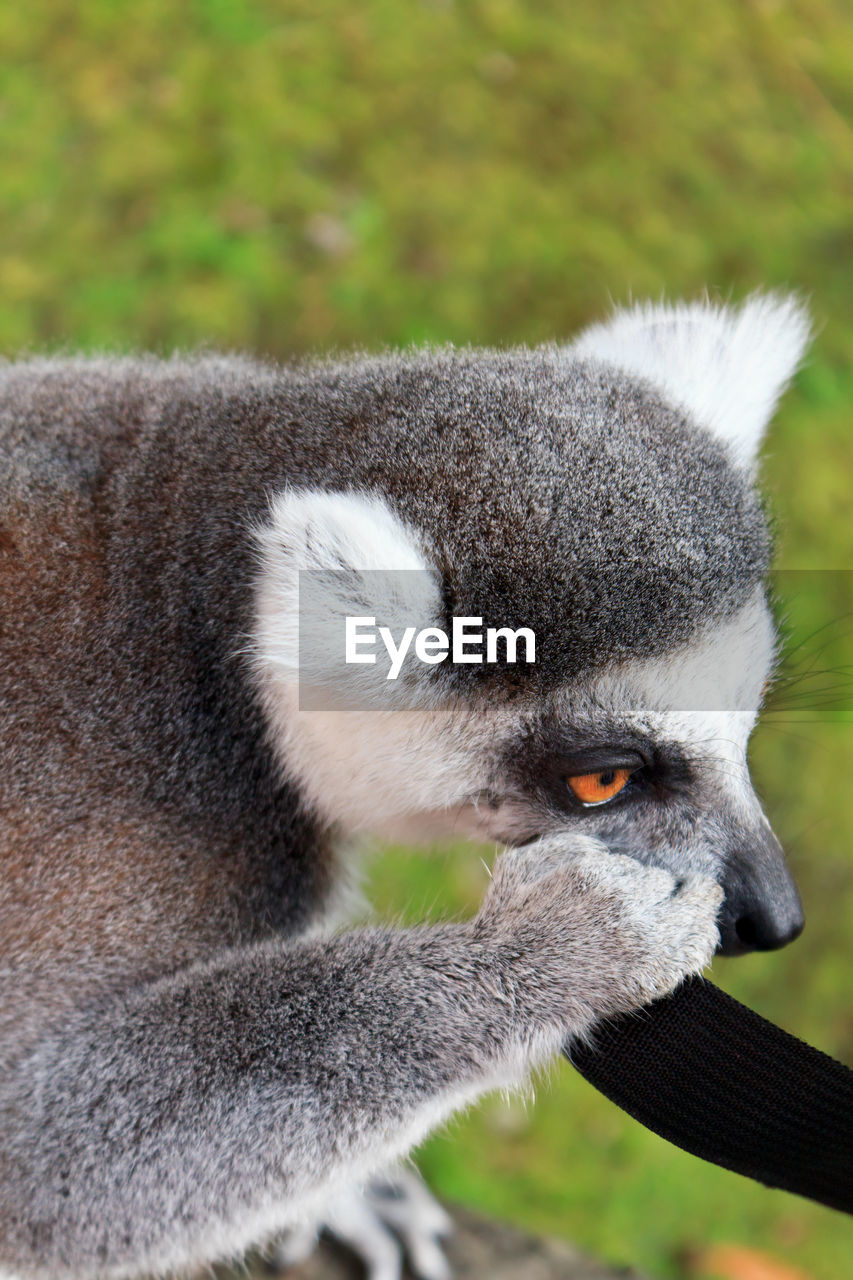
{"left": 273, "top": 1167, "right": 453, "bottom": 1280}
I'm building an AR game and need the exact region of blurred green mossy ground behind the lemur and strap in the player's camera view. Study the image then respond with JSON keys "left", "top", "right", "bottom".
{"left": 0, "top": 0, "right": 853, "bottom": 1280}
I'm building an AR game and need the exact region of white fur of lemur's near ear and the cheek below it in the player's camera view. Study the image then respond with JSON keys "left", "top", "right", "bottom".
{"left": 252, "top": 490, "right": 504, "bottom": 832}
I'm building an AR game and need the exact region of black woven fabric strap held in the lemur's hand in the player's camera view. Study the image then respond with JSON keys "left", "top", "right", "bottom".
{"left": 565, "top": 978, "right": 853, "bottom": 1213}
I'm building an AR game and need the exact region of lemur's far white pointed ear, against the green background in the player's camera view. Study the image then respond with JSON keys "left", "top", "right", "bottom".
{"left": 570, "top": 293, "right": 811, "bottom": 466}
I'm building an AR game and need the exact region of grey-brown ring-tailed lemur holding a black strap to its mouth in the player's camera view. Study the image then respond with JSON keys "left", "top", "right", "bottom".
{"left": 0, "top": 296, "right": 808, "bottom": 1280}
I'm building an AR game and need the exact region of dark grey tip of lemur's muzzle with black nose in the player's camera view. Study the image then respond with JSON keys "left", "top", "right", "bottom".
{"left": 717, "top": 827, "right": 804, "bottom": 956}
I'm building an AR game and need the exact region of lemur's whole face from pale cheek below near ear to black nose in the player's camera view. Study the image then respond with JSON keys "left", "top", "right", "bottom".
{"left": 257, "top": 594, "right": 803, "bottom": 955}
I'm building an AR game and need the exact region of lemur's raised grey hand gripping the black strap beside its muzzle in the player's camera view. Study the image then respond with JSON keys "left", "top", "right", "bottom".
{"left": 474, "top": 835, "right": 722, "bottom": 1032}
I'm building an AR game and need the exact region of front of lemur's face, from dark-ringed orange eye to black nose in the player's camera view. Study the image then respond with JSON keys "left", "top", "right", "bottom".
{"left": 484, "top": 593, "right": 803, "bottom": 955}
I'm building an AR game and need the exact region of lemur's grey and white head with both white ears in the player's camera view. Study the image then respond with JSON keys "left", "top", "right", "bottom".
{"left": 256, "top": 297, "right": 808, "bottom": 954}
